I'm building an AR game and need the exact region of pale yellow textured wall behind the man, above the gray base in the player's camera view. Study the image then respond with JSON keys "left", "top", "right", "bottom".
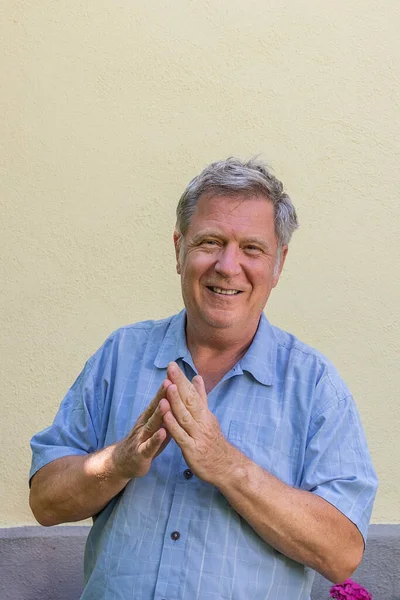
{"left": 0, "top": 0, "right": 400, "bottom": 527}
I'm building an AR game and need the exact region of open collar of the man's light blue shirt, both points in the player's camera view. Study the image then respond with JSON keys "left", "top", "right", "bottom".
{"left": 154, "top": 310, "right": 277, "bottom": 385}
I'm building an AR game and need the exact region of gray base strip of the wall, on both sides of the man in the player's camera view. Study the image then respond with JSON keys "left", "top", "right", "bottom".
{"left": 0, "top": 525, "right": 400, "bottom": 600}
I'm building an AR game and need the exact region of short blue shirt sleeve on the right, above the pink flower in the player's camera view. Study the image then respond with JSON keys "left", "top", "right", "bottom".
{"left": 301, "top": 396, "right": 377, "bottom": 541}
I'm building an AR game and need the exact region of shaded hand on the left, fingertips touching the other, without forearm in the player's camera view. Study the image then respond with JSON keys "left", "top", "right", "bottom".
{"left": 113, "top": 379, "right": 171, "bottom": 479}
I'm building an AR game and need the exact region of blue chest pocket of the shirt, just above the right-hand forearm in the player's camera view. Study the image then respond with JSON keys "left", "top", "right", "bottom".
{"left": 228, "top": 421, "right": 301, "bottom": 485}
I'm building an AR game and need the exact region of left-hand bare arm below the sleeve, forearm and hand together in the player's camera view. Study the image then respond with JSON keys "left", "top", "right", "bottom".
{"left": 29, "top": 379, "right": 171, "bottom": 526}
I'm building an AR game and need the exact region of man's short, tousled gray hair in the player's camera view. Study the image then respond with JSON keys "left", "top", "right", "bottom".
{"left": 176, "top": 157, "right": 299, "bottom": 255}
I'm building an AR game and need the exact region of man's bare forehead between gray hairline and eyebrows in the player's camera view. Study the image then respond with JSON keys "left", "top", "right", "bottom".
{"left": 187, "top": 194, "right": 275, "bottom": 236}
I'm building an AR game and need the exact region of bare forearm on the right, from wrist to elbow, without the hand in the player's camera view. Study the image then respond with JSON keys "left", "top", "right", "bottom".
{"left": 214, "top": 446, "right": 363, "bottom": 582}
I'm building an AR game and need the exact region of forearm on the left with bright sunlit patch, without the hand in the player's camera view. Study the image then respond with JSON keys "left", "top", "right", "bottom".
{"left": 29, "top": 446, "right": 129, "bottom": 526}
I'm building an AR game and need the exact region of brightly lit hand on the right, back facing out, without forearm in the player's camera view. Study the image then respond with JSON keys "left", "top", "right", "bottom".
{"left": 164, "top": 362, "right": 233, "bottom": 485}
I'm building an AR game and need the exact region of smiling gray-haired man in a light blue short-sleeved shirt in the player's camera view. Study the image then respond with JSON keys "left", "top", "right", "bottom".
{"left": 30, "top": 158, "right": 376, "bottom": 600}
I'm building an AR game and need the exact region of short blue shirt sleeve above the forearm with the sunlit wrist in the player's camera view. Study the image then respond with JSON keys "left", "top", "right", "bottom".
{"left": 29, "top": 357, "right": 99, "bottom": 480}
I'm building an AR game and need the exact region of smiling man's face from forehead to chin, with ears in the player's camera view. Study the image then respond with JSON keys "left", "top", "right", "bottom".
{"left": 174, "top": 194, "right": 287, "bottom": 337}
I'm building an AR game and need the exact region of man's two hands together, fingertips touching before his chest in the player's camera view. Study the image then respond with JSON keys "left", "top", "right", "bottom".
{"left": 114, "top": 362, "right": 232, "bottom": 484}
